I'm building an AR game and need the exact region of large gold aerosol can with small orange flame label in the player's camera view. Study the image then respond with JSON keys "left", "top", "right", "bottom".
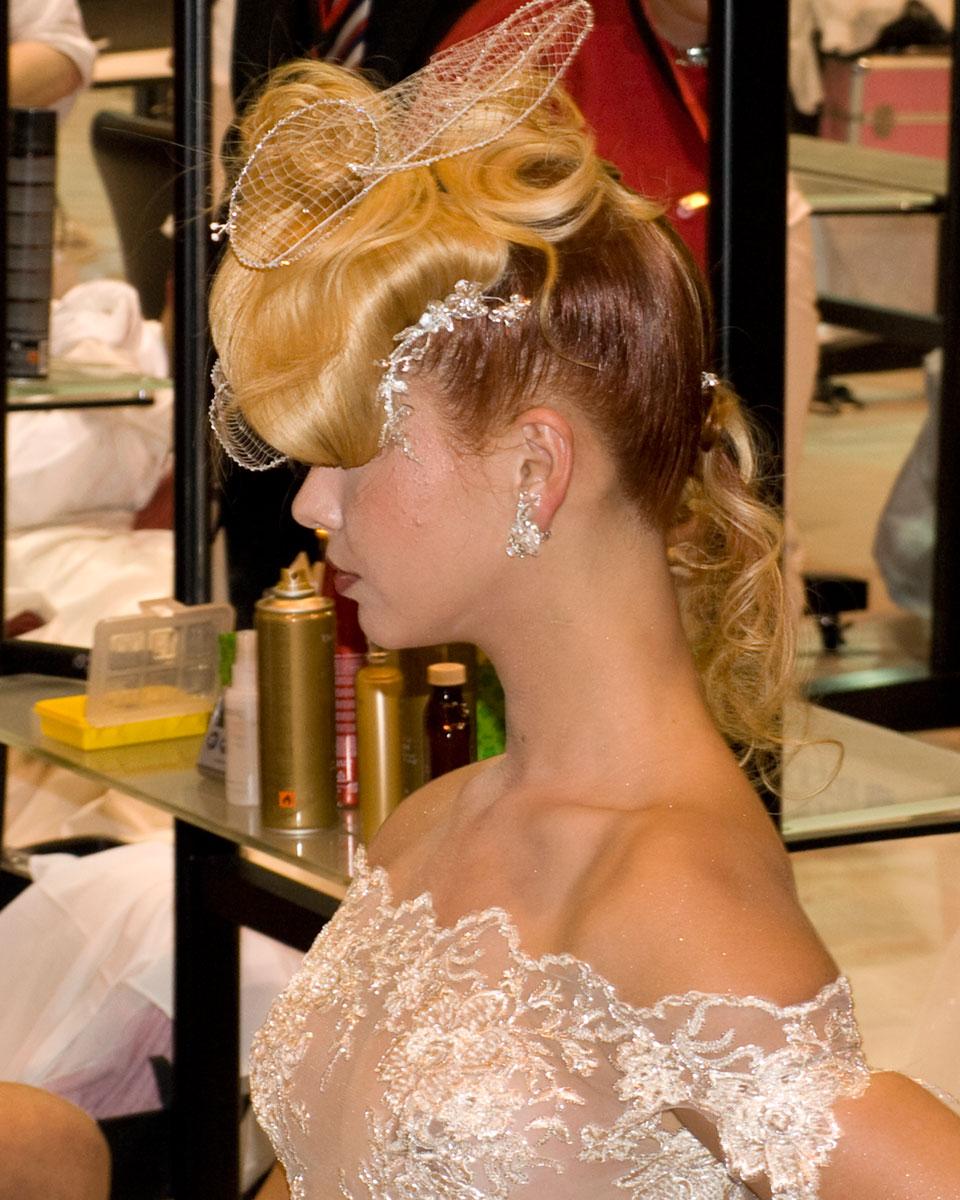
{"left": 254, "top": 568, "right": 337, "bottom": 833}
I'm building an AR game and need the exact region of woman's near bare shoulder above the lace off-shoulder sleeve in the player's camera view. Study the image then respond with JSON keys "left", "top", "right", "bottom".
{"left": 566, "top": 804, "right": 838, "bottom": 1006}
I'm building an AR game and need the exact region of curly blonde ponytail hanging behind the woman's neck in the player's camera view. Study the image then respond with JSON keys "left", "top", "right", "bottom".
{"left": 668, "top": 383, "right": 796, "bottom": 785}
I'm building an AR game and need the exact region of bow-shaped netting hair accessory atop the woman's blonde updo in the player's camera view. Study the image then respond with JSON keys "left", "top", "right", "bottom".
{"left": 211, "top": 0, "right": 593, "bottom": 270}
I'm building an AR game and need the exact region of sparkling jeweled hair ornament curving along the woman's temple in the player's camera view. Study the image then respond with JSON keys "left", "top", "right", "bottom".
{"left": 377, "top": 280, "right": 530, "bottom": 460}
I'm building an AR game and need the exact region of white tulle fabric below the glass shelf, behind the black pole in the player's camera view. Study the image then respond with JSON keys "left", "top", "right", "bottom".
{"left": 0, "top": 841, "right": 301, "bottom": 1116}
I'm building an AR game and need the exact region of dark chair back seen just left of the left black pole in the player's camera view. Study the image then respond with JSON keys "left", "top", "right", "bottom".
{"left": 90, "top": 109, "right": 178, "bottom": 319}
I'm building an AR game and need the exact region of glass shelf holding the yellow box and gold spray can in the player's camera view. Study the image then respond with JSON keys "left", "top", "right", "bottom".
{"left": 0, "top": 674, "right": 356, "bottom": 896}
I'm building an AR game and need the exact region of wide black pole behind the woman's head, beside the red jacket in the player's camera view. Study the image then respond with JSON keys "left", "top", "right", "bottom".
{"left": 709, "top": 0, "right": 788, "bottom": 500}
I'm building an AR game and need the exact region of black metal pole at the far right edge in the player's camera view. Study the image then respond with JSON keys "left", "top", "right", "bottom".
{"left": 930, "top": 2, "right": 960, "bottom": 676}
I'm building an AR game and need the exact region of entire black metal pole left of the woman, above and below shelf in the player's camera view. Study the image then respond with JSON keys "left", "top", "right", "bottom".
{"left": 172, "top": 0, "right": 232, "bottom": 1200}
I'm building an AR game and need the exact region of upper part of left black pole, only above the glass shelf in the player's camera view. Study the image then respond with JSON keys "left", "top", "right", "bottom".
{"left": 174, "top": 0, "right": 216, "bottom": 604}
